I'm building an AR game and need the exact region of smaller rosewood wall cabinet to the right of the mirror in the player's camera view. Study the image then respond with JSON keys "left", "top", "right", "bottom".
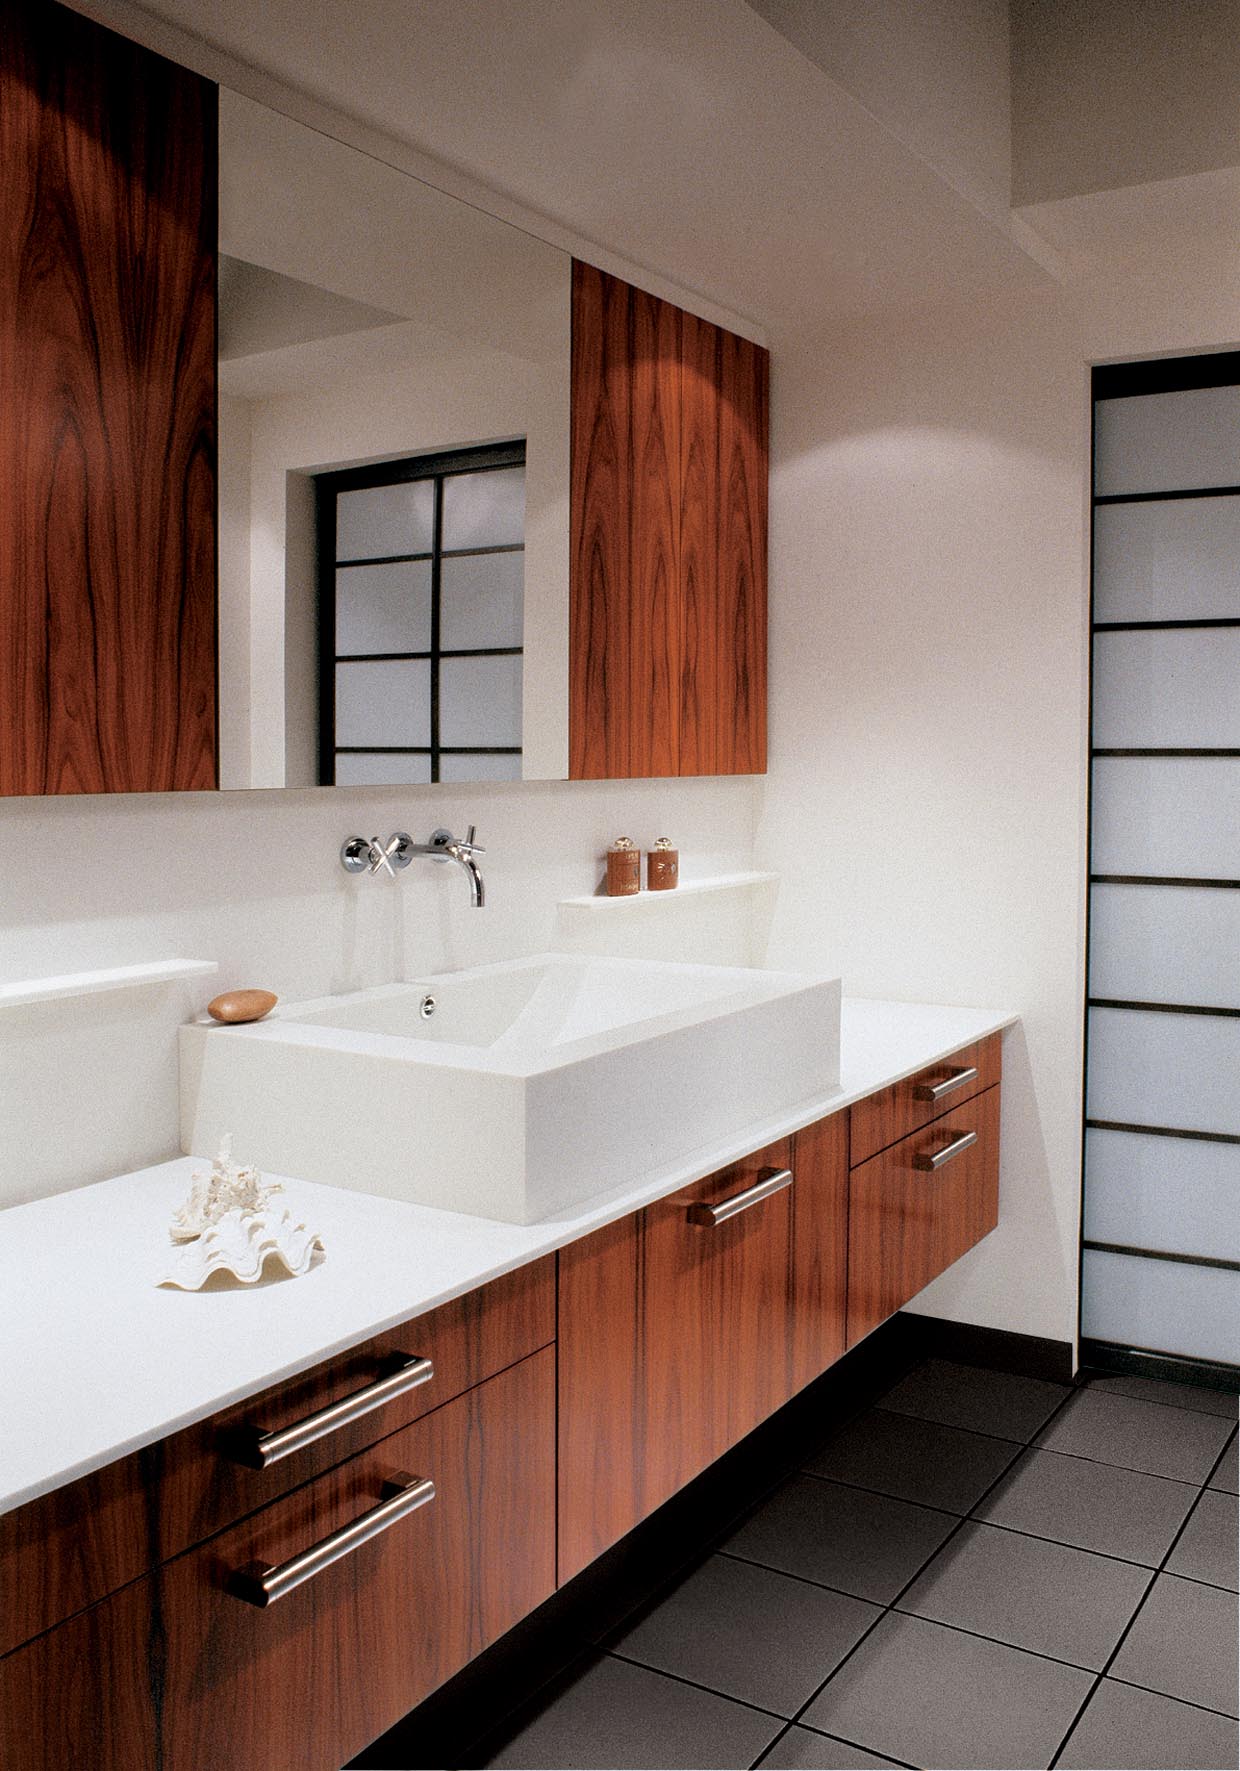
{"left": 569, "top": 262, "right": 769, "bottom": 779}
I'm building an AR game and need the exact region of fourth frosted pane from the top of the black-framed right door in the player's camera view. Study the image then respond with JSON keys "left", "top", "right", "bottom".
{"left": 1093, "top": 756, "right": 1240, "bottom": 878}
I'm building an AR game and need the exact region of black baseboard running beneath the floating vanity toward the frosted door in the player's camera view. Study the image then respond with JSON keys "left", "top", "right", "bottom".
{"left": 353, "top": 1312, "right": 1072, "bottom": 1771}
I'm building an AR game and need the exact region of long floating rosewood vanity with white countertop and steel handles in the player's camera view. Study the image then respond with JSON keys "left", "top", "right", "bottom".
{"left": 0, "top": 998, "right": 1013, "bottom": 1771}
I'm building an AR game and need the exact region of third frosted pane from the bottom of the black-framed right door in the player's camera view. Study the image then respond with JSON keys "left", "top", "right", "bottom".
{"left": 1086, "top": 1008, "right": 1240, "bottom": 1133}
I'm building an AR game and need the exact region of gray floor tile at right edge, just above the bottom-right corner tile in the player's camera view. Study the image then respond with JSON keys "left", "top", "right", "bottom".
{"left": 1109, "top": 1574, "right": 1240, "bottom": 1716}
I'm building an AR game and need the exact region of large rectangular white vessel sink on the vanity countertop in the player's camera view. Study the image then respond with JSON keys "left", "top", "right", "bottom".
{"left": 181, "top": 955, "right": 840, "bottom": 1224}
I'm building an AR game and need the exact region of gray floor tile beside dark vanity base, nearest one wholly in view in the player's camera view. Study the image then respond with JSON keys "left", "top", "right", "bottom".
{"left": 608, "top": 1555, "right": 882, "bottom": 1716}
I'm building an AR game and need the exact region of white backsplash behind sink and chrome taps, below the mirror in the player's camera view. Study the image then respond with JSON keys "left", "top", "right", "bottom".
{"left": 0, "top": 777, "right": 760, "bottom": 1206}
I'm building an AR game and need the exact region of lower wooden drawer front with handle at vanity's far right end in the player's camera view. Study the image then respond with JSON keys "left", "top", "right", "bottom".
{"left": 849, "top": 1087, "right": 999, "bottom": 1346}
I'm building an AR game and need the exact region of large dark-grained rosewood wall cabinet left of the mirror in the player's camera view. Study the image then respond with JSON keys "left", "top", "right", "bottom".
{"left": 0, "top": 0, "right": 216, "bottom": 793}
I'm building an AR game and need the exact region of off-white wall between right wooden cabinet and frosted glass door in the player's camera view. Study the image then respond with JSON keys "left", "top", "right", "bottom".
{"left": 756, "top": 290, "right": 1089, "bottom": 1341}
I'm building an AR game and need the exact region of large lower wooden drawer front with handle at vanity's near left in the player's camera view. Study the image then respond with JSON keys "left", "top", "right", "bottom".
{"left": 154, "top": 1348, "right": 554, "bottom": 1771}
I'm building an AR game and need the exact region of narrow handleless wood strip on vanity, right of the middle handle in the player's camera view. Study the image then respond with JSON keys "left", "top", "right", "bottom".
{"left": 788, "top": 1112, "right": 849, "bottom": 1396}
